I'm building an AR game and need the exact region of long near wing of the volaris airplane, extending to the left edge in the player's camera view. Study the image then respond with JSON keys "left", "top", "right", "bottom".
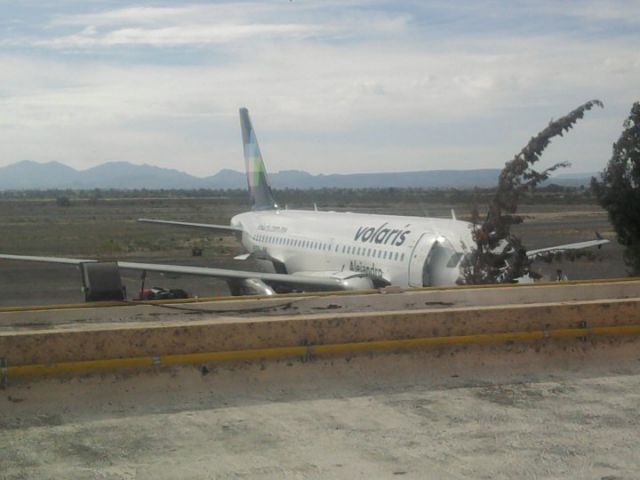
{"left": 0, "top": 254, "right": 370, "bottom": 290}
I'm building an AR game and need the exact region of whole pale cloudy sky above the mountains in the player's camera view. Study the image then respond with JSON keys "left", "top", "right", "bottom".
{"left": 0, "top": 0, "right": 640, "bottom": 176}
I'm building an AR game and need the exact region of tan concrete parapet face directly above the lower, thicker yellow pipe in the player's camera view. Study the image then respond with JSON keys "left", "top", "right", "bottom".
{"left": 0, "top": 299, "right": 640, "bottom": 366}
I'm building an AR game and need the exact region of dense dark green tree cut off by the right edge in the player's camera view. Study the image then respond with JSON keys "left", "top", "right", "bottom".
{"left": 591, "top": 102, "right": 640, "bottom": 275}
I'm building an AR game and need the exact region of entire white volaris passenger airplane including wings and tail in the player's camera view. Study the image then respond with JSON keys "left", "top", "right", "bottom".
{"left": 0, "top": 108, "right": 609, "bottom": 295}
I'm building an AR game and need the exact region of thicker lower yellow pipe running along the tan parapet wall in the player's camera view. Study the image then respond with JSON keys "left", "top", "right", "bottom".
{"left": 4, "top": 325, "right": 640, "bottom": 377}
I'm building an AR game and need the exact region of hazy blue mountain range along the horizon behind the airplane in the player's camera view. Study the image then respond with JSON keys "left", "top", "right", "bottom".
{"left": 0, "top": 160, "right": 592, "bottom": 190}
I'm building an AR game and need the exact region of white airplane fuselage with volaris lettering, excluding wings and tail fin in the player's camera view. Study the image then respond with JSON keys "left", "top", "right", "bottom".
{"left": 231, "top": 210, "right": 473, "bottom": 287}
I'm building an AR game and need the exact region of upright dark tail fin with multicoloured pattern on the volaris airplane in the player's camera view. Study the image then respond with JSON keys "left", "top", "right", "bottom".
{"left": 240, "top": 108, "right": 278, "bottom": 210}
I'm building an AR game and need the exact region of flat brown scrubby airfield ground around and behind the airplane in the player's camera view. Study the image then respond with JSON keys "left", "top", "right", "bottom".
{"left": 0, "top": 191, "right": 626, "bottom": 306}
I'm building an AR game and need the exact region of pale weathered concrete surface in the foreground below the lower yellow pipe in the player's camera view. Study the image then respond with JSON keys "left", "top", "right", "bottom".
{"left": 0, "top": 339, "right": 640, "bottom": 479}
